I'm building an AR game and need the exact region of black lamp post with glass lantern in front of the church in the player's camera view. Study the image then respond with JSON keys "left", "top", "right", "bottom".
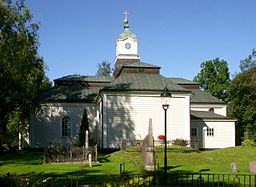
{"left": 161, "top": 87, "right": 171, "bottom": 183}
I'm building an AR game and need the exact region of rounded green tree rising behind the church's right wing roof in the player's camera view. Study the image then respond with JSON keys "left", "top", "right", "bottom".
{"left": 194, "top": 58, "right": 230, "bottom": 102}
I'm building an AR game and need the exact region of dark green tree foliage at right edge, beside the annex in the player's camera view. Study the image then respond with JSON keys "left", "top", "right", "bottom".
{"left": 229, "top": 67, "right": 256, "bottom": 141}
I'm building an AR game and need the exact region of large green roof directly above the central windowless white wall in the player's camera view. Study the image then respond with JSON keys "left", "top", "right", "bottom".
{"left": 103, "top": 73, "right": 191, "bottom": 93}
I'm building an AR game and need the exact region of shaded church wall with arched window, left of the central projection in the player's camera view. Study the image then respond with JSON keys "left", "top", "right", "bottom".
{"left": 30, "top": 103, "right": 98, "bottom": 147}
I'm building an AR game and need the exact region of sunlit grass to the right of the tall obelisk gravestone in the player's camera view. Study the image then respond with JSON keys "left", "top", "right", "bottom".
{"left": 157, "top": 146, "right": 256, "bottom": 174}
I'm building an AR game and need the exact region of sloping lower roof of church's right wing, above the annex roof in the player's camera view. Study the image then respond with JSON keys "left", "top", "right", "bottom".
{"left": 187, "top": 89, "right": 226, "bottom": 104}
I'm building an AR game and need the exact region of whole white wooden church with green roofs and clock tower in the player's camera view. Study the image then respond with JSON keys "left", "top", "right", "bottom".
{"left": 30, "top": 13, "right": 235, "bottom": 149}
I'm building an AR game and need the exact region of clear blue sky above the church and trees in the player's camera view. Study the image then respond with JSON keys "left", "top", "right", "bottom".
{"left": 26, "top": 0, "right": 256, "bottom": 80}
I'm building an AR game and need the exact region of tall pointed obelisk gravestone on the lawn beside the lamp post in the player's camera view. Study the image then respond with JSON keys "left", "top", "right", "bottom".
{"left": 142, "top": 118, "right": 155, "bottom": 171}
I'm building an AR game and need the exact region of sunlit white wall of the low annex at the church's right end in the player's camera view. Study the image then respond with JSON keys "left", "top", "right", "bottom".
{"left": 191, "top": 120, "right": 235, "bottom": 149}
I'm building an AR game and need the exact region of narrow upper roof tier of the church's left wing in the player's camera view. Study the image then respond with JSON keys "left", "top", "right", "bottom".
{"left": 54, "top": 75, "right": 114, "bottom": 82}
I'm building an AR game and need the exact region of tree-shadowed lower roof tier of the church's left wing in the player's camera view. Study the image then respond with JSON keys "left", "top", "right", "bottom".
{"left": 39, "top": 86, "right": 100, "bottom": 102}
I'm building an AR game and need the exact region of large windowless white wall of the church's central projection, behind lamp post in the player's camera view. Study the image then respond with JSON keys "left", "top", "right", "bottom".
{"left": 103, "top": 94, "right": 190, "bottom": 148}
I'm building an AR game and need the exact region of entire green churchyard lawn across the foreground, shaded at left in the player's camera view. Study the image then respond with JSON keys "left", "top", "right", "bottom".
{"left": 0, "top": 146, "right": 256, "bottom": 175}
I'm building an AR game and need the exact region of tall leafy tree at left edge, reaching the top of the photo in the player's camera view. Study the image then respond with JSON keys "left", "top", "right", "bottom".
{"left": 0, "top": 0, "right": 50, "bottom": 151}
